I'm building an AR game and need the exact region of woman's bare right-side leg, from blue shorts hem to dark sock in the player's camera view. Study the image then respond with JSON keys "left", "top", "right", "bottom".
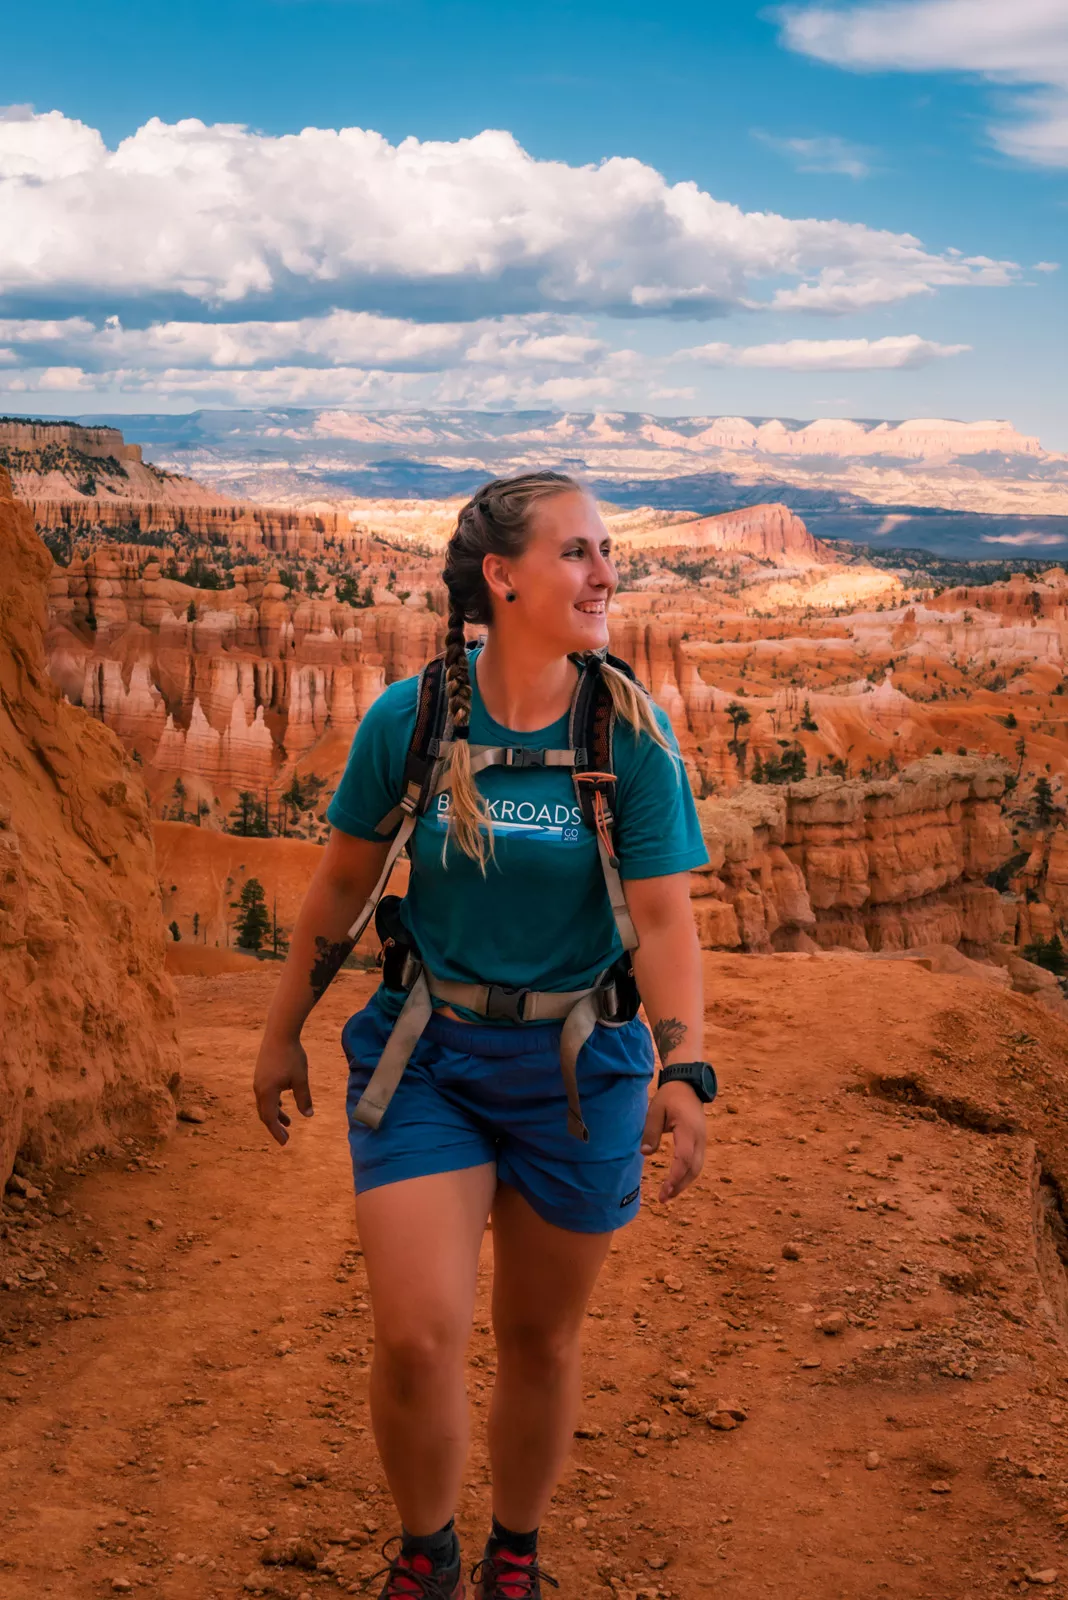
{"left": 489, "top": 1184, "right": 612, "bottom": 1533}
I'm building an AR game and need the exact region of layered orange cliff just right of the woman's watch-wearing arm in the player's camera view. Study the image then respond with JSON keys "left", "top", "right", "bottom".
{"left": 692, "top": 757, "right": 1017, "bottom": 955}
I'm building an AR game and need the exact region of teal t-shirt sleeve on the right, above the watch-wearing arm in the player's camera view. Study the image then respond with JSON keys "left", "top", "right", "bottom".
{"left": 616, "top": 706, "right": 708, "bottom": 878}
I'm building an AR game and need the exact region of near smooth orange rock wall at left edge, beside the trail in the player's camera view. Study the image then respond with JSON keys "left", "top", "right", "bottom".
{"left": 0, "top": 469, "right": 177, "bottom": 1184}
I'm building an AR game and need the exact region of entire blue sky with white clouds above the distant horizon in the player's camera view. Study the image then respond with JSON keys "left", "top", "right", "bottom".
{"left": 0, "top": 0, "right": 1068, "bottom": 450}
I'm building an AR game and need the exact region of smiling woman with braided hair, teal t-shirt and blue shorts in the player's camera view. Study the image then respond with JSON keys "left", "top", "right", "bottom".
{"left": 256, "top": 472, "right": 715, "bottom": 1600}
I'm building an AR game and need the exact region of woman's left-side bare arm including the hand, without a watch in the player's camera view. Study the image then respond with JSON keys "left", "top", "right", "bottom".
{"left": 253, "top": 829, "right": 389, "bottom": 1144}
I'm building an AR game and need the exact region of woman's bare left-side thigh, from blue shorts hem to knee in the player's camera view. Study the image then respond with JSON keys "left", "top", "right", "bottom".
{"left": 357, "top": 1163, "right": 497, "bottom": 1355}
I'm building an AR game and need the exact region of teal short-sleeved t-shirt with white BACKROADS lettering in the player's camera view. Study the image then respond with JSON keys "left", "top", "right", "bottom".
{"left": 326, "top": 650, "right": 708, "bottom": 997}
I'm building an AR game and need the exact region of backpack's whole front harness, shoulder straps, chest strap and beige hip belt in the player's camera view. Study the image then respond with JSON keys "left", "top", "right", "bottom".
{"left": 347, "top": 651, "right": 640, "bottom": 1142}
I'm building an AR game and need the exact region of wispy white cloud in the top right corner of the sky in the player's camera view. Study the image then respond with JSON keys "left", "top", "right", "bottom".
{"left": 780, "top": 0, "right": 1068, "bottom": 166}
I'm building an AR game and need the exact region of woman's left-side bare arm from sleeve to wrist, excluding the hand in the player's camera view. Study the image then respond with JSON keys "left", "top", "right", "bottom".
{"left": 264, "top": 835, "right": 387, "bottom": 1038}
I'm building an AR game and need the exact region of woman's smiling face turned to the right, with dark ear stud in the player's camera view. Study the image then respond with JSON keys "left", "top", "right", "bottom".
{"left": 483, "top": 490, "right": 619, "bottom": 656}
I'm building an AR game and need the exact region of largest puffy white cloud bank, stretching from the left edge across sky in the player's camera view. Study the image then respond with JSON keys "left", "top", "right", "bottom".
{"left": 0, "top": 112, "right": 1017, "bottom": 318}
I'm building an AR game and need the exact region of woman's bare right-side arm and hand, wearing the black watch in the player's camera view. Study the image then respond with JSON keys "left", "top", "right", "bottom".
{"left": 624, "top": 872, "right": 705, "bottom": 1200}
